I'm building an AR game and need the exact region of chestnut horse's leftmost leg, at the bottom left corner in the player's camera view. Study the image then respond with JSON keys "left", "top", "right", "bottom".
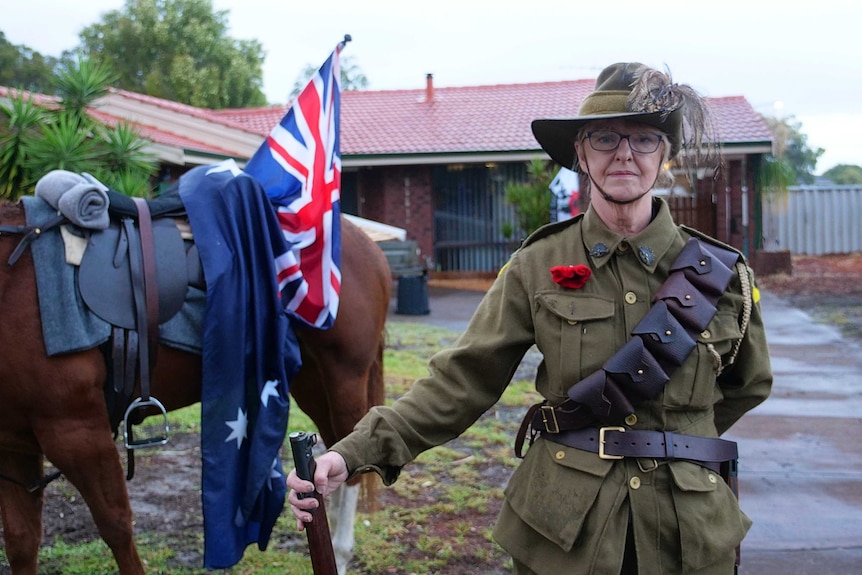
{"left": 0, "top": 451, "right": 42, "bottom": 575}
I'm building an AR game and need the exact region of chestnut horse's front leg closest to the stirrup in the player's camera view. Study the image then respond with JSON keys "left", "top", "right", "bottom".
{"left": 33, "top": 350, "right": 144, "bottom": 575}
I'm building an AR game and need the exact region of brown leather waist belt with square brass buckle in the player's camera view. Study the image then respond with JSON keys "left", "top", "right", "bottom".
{"left": 542, "top": 427, "right": 738, "bottom": 473}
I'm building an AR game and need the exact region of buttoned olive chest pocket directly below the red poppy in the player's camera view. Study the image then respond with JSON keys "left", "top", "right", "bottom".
{"left": 535, "top": 291, "right": 615, "bottom": 399}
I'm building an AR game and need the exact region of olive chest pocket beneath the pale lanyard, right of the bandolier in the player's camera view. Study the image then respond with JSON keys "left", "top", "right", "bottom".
{"left": 663, "top": 311, "right": 742, "bottom": 409}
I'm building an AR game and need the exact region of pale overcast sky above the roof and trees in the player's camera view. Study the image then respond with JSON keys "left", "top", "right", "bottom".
{"left": 0, "top": 0, "right": 862, "bottom": 173}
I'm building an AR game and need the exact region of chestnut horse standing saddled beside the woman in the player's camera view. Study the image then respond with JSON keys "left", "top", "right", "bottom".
{"left": 0, "top": 202, "right": 391, "bottom": 575}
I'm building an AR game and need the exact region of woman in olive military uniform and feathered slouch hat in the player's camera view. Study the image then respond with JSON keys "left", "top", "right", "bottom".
{"left": 287, "top": 63, "right": 772, "bottom": 575}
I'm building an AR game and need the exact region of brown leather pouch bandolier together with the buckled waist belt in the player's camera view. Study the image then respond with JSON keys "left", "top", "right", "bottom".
{"left": 515, "top": 238, "right": 740, "bottom": 479}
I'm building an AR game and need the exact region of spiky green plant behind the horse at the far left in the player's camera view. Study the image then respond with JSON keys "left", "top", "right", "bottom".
{"left": 0, "top": 61, "right": 157, "bottom": 200}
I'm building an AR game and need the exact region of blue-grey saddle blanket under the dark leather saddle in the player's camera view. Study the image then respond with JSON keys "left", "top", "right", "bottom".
{"left": 21, "top": 196, "right": 206, "bottom": 356}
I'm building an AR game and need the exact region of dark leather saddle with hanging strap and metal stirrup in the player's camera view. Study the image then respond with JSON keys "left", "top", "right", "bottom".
{"left": 78, "top": 190, "right": 205, "bottom": 479}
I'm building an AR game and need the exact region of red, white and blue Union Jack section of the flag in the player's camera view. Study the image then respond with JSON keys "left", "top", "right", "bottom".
{"left": 245, "top": 37, "right": 349, "bottom": 329}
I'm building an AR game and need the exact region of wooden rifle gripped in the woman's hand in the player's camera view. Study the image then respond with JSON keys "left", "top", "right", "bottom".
{"left": 290, "top": 431, "right": 338, "bottom": 575}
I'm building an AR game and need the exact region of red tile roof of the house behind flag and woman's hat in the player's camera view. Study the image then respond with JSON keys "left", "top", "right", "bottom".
{"left": 211, "top": 80, "right": 772, "bottom": 156}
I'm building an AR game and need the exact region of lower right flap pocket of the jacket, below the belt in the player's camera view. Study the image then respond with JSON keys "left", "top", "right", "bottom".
{"left": 669, "top": 461, "right": 751, "bottom": 572}
